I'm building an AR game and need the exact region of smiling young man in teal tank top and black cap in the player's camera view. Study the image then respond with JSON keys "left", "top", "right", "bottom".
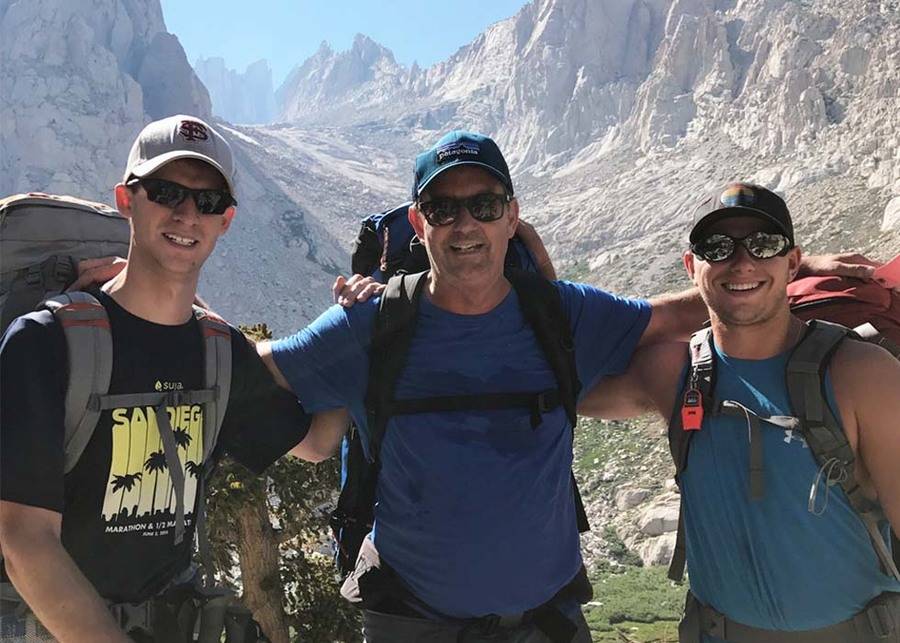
{"left": 579, "top": 184, "right": 900, "bottom": 643}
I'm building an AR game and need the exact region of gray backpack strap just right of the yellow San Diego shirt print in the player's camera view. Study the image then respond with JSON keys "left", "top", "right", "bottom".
{"left": 194, "top": 306, "right": 231, "bottom": 464}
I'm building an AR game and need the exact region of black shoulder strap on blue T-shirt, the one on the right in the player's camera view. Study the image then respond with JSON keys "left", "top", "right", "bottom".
{"left": 506, "top": 269, "right": 581, "bottom": 432}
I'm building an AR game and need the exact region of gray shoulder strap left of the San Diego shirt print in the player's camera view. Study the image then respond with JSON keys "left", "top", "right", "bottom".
{"left": 43, "top": 292, "right": 113, "bottom": 473}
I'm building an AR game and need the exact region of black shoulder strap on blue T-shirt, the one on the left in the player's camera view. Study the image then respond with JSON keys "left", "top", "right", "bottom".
{"left": 365, "top": 271, "right": 428, "bottom": 462}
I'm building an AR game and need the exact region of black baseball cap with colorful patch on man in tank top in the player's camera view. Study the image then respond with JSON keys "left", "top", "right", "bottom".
{"left": 690, "top": 183, "right": 794, "bottom": 246}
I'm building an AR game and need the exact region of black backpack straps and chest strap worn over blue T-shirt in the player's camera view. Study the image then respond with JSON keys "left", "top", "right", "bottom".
{"left": 330, "top": 270, "right": 589, "bottom": 575}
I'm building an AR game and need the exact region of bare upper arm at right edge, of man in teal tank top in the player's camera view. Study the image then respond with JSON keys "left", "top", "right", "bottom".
{"left": 832, "top": 342, "right": 900, "bottom": 533}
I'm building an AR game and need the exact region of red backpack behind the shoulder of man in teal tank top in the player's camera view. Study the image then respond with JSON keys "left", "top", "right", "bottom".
{"left": 788, "top": 276, "right": 900, "bottom": 357}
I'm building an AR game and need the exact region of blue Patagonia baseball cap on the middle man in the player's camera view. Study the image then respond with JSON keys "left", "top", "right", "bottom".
{"left": 413, "top": 130, "right": 513, "bottom": 201}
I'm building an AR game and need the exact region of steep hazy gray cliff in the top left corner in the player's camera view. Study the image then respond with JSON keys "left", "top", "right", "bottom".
{"left": 0, "top": 0, "right": 210, "bottom": 200}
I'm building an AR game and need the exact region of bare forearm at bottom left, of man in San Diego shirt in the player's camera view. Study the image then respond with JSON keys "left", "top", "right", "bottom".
{"left": 0, "top": 500, "right": 131, "bottom": 643}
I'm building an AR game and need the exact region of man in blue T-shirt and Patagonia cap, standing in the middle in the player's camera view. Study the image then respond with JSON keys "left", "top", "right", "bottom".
{"left": 260, "top": 132, "right": 716, "bottom": 643}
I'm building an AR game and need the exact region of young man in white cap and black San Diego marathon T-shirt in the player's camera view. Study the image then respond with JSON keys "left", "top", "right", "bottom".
{"left": 0, "top": 116, "right": 328, "bottom": 642}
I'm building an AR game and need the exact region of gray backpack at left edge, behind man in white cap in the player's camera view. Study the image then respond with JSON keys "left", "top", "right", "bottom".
{"left": 0, "top": 192, "right": 130, "bottom": 332}
